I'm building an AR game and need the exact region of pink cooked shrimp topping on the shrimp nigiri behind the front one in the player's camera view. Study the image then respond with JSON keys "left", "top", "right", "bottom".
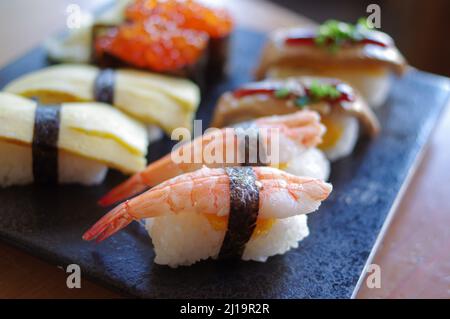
{"left": 99, "top": 110, "right": 325, "bottom": 206}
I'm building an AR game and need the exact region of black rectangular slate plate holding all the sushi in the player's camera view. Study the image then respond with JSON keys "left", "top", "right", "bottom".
{"left": 0, "top": 29, "right": 449, "bottom": 298}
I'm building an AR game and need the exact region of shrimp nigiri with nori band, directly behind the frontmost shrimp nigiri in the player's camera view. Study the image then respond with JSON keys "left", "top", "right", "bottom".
{"left": 99, "top": 110, "right": 330, "bottom": 206}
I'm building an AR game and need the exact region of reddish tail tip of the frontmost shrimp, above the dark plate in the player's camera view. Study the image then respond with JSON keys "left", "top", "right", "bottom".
{"left": 83, "top": 201, "right": 134, "bottom": 242}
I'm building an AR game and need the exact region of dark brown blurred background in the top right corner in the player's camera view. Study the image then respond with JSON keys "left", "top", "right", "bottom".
{"left": 272, "top": 0, "right": 450, "bottom": 76}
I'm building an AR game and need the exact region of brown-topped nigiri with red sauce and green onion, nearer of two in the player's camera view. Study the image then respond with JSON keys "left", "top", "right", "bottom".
{"left": 211, "top": 77, "right": 380, "bottom": 161}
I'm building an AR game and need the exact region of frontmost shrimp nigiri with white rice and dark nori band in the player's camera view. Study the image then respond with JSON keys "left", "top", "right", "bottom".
{"left": 83, "top": 167, "right": 332, "bottom": 267}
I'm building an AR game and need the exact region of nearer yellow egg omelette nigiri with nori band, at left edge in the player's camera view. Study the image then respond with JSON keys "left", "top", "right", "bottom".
{"left": 0, "top": 93, "right": 148, "bottom": 187}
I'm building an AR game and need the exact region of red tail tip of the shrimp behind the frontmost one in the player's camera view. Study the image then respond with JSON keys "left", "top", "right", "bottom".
{"left": 98, "top": 173, "right": 150, "bottom": 207}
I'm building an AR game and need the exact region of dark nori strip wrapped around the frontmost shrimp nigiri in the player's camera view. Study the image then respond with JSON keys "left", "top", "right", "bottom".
{"left": 219, "top": 167, "right": 259, "bottom": 259}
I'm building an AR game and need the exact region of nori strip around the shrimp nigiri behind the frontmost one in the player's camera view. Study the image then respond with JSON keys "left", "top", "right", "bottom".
{"left": 233, "top": 121, "right": 268, "bottom": 166}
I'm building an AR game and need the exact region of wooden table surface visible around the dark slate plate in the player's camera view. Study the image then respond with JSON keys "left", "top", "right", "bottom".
{"left": 0, "top": 0, "right": 450, "bottom": 298}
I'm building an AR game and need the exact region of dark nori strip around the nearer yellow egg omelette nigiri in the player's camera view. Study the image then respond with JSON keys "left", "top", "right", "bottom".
{"left": 31, "top": 104, "right": 61, "bottom": 184}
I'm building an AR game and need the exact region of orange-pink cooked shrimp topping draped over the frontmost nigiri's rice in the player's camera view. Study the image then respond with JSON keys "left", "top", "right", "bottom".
{"left": 83, "top": 167, "right": 332, "bottom": 241}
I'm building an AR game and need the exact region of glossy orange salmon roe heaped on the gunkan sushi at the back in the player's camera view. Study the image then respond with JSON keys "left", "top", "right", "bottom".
{"left": 95, "top": 0, "right": 232, "bottom": 72}
